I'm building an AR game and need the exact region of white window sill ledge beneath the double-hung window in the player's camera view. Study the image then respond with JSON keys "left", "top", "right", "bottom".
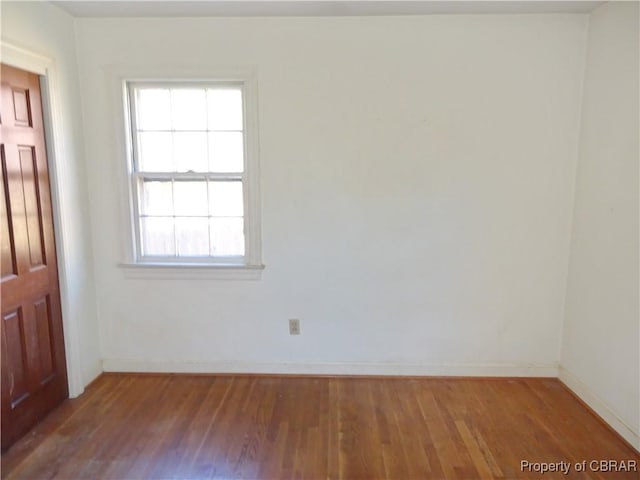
{"left": 118, "top": 263, "right": 264, "bottom": 280}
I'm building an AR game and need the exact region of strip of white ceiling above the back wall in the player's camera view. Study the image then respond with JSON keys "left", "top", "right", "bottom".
{"left": 51, "top": 0, "right": 605, "bottom": 17}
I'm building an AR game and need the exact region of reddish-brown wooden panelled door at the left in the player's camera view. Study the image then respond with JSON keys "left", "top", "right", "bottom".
{"left": 0, "top": 65, "right": 68, "bottom": 450}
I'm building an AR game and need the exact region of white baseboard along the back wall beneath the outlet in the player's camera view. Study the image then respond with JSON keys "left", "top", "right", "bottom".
{"left": 103, "top": 358, "right": 558, "bottom": 377}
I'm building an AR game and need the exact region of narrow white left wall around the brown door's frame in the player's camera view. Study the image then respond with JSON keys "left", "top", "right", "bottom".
{"left": 1, "top": 1, "right": 102, "bottom": 395}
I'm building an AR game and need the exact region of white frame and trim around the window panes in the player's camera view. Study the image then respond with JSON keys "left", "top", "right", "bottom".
{"left": 117, "top": 71, "right": 264, "bottom": 280}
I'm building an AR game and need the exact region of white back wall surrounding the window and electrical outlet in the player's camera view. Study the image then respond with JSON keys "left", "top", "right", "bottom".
{"left": 77, "top": 15, "right": 586, "bottom": 376}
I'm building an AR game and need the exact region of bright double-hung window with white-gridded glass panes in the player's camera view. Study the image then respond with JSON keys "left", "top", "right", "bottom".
{"left": 126, "top": 81, "right": 260, "bottom": 266}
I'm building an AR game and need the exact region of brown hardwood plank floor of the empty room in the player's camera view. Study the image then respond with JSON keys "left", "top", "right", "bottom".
{"left": 2, "top": 374, "right": 640, "bottom": 480}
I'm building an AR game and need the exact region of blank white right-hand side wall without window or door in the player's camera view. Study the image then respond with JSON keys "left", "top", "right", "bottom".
{"left": 561, "top": 2, "right": 640, "bottom": 449}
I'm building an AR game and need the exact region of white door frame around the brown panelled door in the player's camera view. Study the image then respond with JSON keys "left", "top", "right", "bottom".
{"left": 0, "top": 39, "right": 84, "bottom": 398}
